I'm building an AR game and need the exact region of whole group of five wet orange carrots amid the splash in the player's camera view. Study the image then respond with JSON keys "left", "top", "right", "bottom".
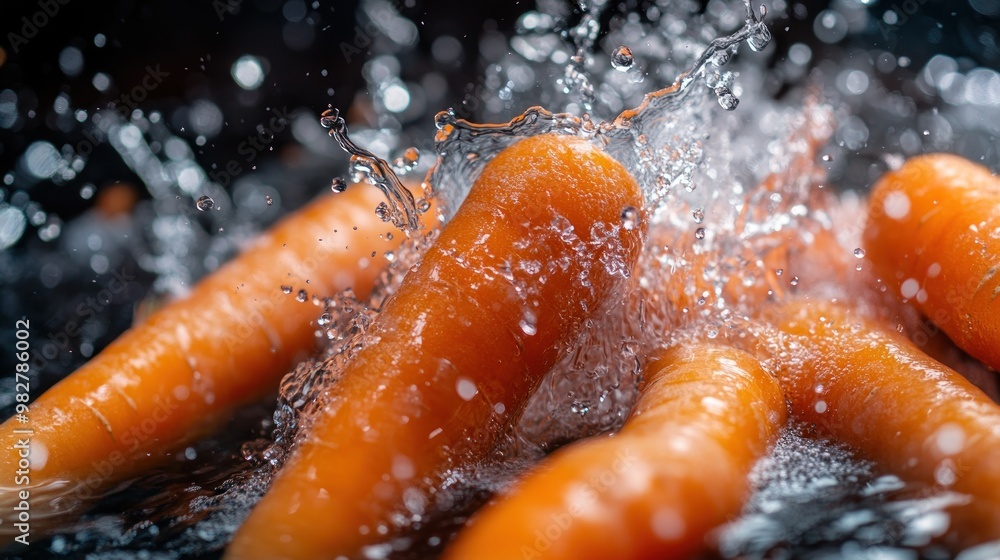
{"left": 0, "top": 128, "right": 1000, "bottom": 559}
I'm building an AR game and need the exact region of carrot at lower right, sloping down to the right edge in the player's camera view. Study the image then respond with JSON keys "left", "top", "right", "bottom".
{"left": 775, "top": 302, "right": 1000, "bottom": 546}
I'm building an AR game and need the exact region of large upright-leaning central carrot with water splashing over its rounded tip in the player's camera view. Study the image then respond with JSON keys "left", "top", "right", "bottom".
{"left": 227, "top": 135, "right": 644, "bottom": 559}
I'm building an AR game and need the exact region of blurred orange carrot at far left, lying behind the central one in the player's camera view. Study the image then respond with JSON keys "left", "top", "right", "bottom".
{"left": 0, "top": 187, "right": 395, "bottom": 536}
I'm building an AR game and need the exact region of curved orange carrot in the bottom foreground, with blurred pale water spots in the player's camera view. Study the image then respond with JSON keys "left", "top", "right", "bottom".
{"left": 445, "top": 343, "right": 786, "bottom": 560}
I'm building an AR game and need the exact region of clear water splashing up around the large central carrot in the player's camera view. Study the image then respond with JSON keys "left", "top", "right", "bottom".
{"left": 13, "top": 0, "right": 1000, "bottom": 558}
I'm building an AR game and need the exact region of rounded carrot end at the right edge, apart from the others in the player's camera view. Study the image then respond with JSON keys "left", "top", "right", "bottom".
{"left": 865, "top": 154, "right": 1000, "bottom": 369}
